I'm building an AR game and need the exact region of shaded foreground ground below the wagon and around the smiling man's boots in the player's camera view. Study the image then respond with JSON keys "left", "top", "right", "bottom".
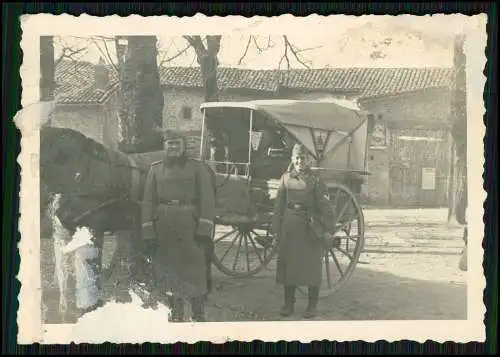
{"left": 207, "top": 266, "right": 467, "bottom": 321}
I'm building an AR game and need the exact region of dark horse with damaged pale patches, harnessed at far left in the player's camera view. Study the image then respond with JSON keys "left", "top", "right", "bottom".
{"left": 40, "top": 126, "right": 164, "bottom": 316}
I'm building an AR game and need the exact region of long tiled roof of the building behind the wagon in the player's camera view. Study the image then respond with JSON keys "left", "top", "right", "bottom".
{"left": 56, "top": 61, "right": 453, "bottom": 104}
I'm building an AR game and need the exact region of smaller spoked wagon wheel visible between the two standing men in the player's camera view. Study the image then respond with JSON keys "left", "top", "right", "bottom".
{"left": 213, "top": 216, "right": 276, "bottom": 278}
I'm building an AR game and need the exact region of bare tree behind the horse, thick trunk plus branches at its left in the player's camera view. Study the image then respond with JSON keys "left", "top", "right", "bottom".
{"left": 55, "top": 36, "right": 163, "bottom": 152}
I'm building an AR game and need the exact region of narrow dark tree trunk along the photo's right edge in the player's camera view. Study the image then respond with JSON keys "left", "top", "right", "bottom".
{"left": 449, "top": 36, "right": 467, "bottom": 221}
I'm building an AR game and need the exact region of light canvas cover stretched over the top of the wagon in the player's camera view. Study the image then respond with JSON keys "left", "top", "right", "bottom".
{"left": 201, "top": 99, "right": 368, "bottom": 171}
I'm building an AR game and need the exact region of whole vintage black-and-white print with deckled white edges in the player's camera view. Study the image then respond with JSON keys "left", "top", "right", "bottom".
{"left": 16, "top": 15, "right": 486, "bottom": 343}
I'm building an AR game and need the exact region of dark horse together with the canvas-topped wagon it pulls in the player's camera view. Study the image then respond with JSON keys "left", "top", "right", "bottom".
{"left": 40, "top": 100, "right": 371, "bottom": 314}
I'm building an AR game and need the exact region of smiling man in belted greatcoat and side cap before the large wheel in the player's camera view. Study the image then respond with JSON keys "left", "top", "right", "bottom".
{"left": 272, "top": 144, "right": 333, "bottom": 318}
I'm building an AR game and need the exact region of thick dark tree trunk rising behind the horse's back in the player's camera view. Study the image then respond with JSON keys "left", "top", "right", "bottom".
{"left": 117, "top": 36, "right": 164, "bottom": 153}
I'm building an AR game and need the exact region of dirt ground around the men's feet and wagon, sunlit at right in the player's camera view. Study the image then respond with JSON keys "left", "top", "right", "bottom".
{"left": 42, "top": 209, "right": 467, "bottom": 323}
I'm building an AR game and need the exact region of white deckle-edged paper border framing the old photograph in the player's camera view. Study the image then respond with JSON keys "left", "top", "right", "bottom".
{"left": 14, "top": 14, "right": 487, "bottom": 344}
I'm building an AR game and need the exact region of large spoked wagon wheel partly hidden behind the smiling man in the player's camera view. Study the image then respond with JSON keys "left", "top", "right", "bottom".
{"left": 299, "top": 183, "right": 365, "bottom": 297}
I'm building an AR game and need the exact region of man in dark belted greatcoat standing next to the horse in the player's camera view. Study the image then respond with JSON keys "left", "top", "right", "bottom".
{"left": 142, "top": 132, "right": 215, "bottom": 321}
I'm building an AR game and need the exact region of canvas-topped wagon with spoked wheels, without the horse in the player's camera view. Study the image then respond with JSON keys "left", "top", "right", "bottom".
{"left": 200, "top": 100, "right": 372, "bottom": 293}
